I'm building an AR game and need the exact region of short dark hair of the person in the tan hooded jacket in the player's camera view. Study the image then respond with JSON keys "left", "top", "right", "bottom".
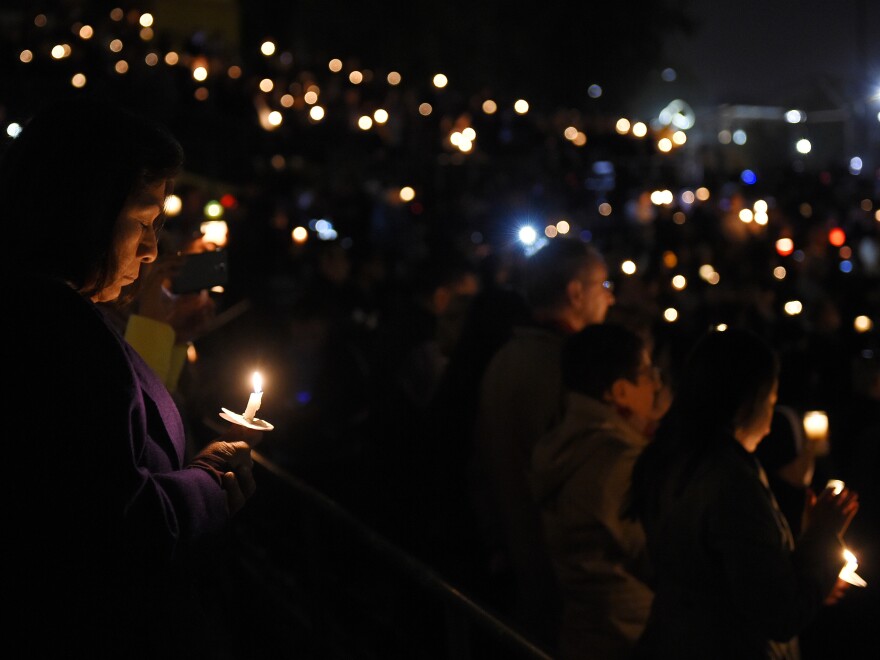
{"left": 562, "top": 323, "right": 647, "bottom": 400}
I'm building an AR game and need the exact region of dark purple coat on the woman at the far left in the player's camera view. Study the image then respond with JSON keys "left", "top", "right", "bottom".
{"left": 2, "top": 277, "right": 229, "bottom": 657}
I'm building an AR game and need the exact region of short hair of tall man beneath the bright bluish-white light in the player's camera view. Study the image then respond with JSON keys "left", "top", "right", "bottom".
{"left": 525, "top": 238, "right": 605, "bottom": 310}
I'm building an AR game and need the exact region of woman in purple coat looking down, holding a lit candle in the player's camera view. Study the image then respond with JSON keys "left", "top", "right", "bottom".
{"left": 0, "top": 95, "right": 258, "bottom": 658}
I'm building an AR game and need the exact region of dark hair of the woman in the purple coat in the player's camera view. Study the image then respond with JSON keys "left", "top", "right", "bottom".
{"left": 0, "top": 96, "right": 183, "bottom": 295}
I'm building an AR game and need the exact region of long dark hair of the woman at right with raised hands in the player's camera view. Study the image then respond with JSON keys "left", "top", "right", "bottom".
{"left": 629, "top": 329, "right": 779, "bottom": 517}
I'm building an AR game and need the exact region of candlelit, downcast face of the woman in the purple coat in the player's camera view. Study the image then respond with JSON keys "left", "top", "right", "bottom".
{"left": 92, "top": 181, "right": 166, "bottom": 302}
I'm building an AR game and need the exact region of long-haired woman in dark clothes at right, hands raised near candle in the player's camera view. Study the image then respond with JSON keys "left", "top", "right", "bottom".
{"left": 630, "top": 329, "right": 858, "bottom": 660}
